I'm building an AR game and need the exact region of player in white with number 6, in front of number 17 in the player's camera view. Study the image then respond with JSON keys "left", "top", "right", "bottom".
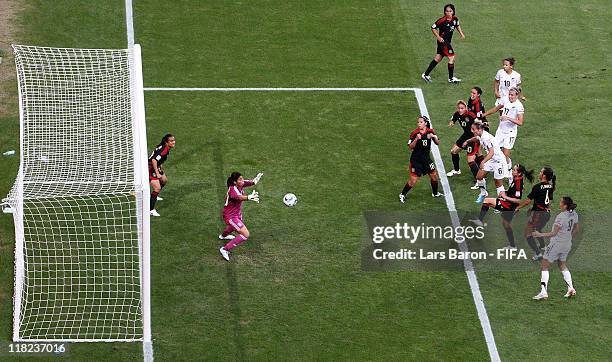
{"left": 463, "top": 121, "right": 507, "bottom": 204}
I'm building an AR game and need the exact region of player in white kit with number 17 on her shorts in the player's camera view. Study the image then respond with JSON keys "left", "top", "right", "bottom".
{"left": 483, "top": 87, "right": 525, "bottom": 182}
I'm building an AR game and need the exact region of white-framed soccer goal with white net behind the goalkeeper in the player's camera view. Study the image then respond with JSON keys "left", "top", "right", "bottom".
{"left": 3, "top": 45, "right": 152, "bottom": 359}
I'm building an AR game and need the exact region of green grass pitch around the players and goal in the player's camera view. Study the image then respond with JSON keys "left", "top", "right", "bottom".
{"left": 0, "top": 0, "right": 612, "bottom": 361}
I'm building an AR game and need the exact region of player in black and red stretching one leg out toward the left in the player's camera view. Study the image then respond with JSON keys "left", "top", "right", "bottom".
{"left": 470, "top": 164, "right": 533, "bottom": 249}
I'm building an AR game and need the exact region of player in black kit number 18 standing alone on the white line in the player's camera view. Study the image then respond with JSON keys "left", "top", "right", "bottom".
{"left": 399, "top": 116, "right": 444, "bottom": 204}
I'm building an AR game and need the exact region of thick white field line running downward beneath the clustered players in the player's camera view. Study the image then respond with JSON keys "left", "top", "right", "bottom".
{"left": 414, "top": 88, "right": 500, "bottom": 362}
